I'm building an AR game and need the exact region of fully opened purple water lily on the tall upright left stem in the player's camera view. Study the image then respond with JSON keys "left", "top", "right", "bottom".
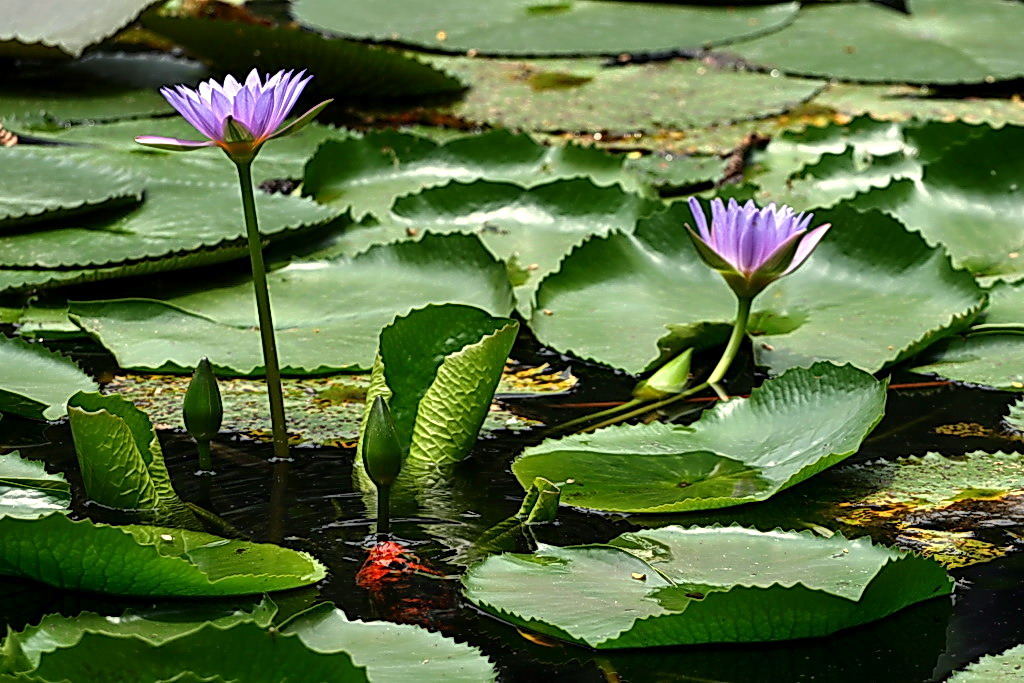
{"left": 135, "top": 69, "right": 331, "bottom": 162}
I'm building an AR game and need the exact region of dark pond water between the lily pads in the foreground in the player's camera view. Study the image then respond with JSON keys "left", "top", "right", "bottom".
{"left": 0, "top": 343, "right": 1024, "bottom": 683}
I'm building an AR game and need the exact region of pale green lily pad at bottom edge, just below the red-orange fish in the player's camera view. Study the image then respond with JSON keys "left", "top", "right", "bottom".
{"left": 282, "top": 602, "right": 496, "bottom": 683}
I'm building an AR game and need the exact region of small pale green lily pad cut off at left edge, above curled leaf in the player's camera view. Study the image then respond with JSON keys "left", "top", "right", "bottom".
{"left": 0, "top": 335, "right": 97, "bottom": 420}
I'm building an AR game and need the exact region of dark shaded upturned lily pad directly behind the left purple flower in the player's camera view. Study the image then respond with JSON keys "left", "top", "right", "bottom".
{"left": 142, "top": 14, "right": 463, "bottom": 100}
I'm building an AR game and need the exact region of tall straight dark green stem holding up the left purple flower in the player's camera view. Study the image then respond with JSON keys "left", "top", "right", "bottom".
{"left": 234, "top": 160, "right": 289, "bottom": 459}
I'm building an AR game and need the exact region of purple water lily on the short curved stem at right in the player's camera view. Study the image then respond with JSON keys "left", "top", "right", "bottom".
{"left": 686, "top": 197, "right": 829, "bottom": 298}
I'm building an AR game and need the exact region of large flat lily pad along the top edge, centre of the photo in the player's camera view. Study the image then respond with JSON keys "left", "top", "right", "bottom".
{"left": 292, "top": 0, "right": 797, "bottom": 55}
